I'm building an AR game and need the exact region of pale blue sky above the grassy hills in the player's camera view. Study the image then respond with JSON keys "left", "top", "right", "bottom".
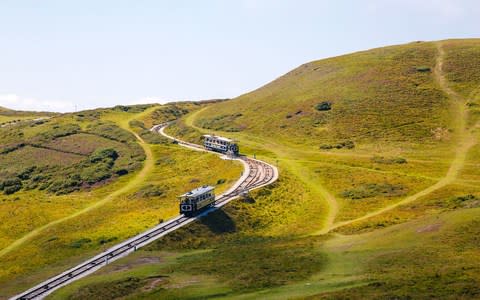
{"left": 0, "top": 0, "right": 480, "bottom": 111}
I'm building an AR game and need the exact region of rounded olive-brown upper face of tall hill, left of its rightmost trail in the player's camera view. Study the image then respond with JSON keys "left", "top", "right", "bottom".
{"left": 192, "top": 43, "right": 450, "bottom": 148}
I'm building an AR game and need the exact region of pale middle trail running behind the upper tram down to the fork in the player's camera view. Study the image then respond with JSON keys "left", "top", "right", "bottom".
{"left": 184, "top": 107, "right": 339, "bottom": 233}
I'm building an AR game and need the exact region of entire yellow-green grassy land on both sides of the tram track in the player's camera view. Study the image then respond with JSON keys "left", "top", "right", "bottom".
{"left": 0, "top": 40, "right": 480, "bottom": 299}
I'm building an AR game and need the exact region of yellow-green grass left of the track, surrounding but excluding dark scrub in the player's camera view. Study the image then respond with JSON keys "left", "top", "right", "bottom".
{"left": 0, "top": 103, "right": 242, "bottom": 297}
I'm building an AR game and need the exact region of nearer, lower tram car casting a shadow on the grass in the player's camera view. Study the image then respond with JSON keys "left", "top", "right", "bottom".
{"left": 178, "top": 185, "right": 215, "bottom": 217}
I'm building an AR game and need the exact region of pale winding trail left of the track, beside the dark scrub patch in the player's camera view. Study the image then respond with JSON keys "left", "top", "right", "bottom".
{"left": 0, "top": 107, "right": 155, "bottom": 258}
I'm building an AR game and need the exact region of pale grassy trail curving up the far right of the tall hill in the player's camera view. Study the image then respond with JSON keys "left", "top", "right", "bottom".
{"left": 329, "top": 43, "right": 478, "bottom": 231}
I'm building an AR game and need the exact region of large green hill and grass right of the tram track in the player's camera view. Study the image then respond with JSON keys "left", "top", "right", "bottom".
{"left": 8, "top": 39, "right": 480, "bottom": 299}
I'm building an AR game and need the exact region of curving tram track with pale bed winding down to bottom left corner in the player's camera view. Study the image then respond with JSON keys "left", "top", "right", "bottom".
{"left": 11, "top": 123, "right": 278, "bottom": 300}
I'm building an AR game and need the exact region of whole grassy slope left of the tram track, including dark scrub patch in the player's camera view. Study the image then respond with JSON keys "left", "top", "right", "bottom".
{"left": 0, "top": 105, "right": 242, "bottom": 298}
